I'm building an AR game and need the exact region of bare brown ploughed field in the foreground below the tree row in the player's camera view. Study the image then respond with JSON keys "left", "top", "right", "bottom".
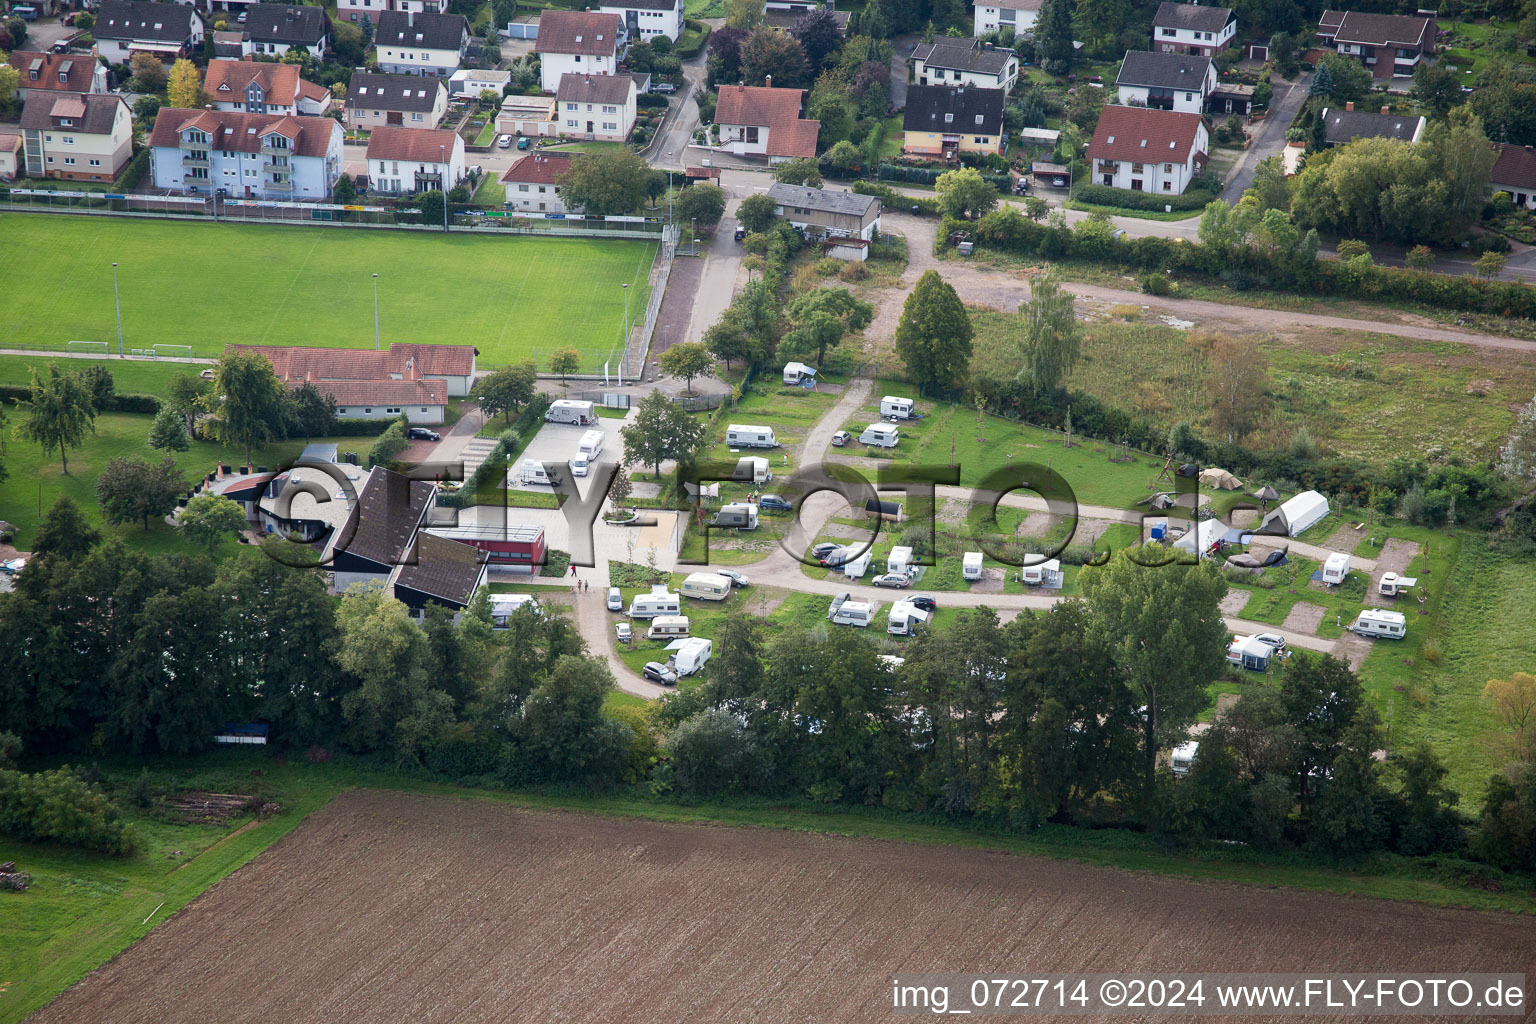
{"left": 34, "top": 792, "right": 1536, "bottom": 1024}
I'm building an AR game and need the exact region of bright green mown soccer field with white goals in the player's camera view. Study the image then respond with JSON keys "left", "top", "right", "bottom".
{"left": 0, "top": 213, "right": 656, "bottom": 373}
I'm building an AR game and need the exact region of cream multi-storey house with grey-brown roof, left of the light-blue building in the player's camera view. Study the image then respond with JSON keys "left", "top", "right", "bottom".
{"left": 22, "top": 92, "right": 134, "bottom": 181}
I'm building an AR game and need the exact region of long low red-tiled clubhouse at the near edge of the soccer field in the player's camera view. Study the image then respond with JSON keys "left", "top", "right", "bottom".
{"left": 229, "top": 342, "right": 475, "bottom": 396}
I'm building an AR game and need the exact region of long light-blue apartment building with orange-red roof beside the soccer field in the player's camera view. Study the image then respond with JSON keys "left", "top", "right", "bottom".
{"left": 149, "top": 107, "right": 346, "bottom": 200}
